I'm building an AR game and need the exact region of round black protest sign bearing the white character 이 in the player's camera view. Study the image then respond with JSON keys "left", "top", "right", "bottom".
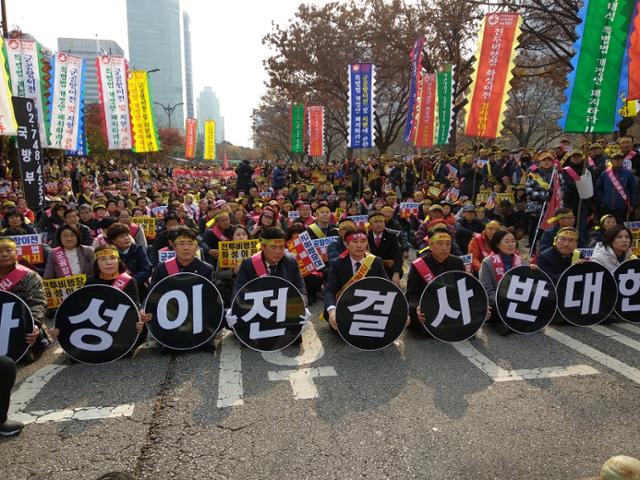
{"left": 145, "top": 272, "right": 224, "bottom": 350}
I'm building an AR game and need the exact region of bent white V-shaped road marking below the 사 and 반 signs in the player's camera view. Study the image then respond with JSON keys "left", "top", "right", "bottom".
{"left": 452, "top": 342, "right": 600, "bottom": 382}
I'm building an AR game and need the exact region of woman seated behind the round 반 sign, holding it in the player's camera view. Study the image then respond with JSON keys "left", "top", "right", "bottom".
{"left": 479, "top": 230, "right": 537, "bottom": 335}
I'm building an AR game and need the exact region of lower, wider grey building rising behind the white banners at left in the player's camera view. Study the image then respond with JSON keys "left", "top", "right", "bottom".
{"left": 58, "top": 38, "right": 124, "bottom": 104}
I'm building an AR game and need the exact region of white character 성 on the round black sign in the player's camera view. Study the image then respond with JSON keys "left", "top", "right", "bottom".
{"left": 69, "top": 298, "right": 131, "bottom": 352}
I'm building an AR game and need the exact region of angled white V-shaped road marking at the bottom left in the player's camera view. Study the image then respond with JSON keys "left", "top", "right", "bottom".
{"left": 9, "top": 364, "right": 135, "bottom": 424}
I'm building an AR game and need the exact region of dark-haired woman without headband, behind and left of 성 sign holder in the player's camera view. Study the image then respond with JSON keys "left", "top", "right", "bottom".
{"left": 43, "top": 224, "right": 94, "bottom": 278}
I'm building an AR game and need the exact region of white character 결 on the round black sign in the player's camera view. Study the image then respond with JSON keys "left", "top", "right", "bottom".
{"left": 349, "top": 289, "right": 398, "bottom": 338}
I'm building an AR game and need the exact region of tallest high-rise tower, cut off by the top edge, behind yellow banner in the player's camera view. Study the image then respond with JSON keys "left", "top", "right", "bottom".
{"left": 127, "top": 0, "right": 185, "bottom": 129}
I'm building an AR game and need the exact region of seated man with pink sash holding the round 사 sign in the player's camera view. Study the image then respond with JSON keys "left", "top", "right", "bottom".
{"left": 405, "top": 227, "right": 465, "bottom": 328}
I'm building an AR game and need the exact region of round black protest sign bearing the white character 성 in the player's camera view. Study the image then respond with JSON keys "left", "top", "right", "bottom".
{"left": 55, "top": 285, "right": 138, "bottom": 365}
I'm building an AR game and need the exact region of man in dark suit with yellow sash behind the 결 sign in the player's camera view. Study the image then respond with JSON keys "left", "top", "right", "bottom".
{"left": 324, "top": 229, "right": 389, "bottom": 330}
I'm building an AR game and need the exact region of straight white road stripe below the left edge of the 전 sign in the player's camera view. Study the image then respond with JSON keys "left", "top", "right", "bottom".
{"left": 217, "top": 332, "right": 244, "bottom": 408}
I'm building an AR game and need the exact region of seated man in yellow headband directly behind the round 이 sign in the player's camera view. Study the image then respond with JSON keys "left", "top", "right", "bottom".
{"left": 151, "top": 226, "right": 213, "bottom": 285}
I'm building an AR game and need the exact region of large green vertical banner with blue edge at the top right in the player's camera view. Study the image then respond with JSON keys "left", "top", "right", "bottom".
{"left": 559, "top": 0, "right": 636, "bottom": 133}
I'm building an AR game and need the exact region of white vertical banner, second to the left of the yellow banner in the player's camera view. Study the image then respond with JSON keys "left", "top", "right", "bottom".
{"left": 49, "top": 52, "right": 84, "bottom": 151}
